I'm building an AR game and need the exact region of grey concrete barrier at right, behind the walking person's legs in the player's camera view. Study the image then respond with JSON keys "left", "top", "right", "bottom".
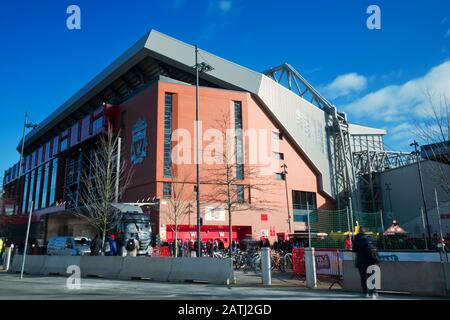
{"left": 343, "top": 260, "right": 449, "bottom": 296}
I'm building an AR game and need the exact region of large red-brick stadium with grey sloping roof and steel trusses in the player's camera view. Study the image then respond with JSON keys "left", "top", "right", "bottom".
{"left": 1, "top": 30, "right": 412, "bottom": 245}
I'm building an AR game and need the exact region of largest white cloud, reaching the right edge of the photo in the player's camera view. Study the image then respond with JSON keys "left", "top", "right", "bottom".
{"left": 343, "top": 61, "right": 450, "bottom": 122}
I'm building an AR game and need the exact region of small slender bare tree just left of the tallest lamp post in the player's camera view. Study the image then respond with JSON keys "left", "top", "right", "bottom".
{"left": 167, "top": 175, "right": 191, "bottom": 257}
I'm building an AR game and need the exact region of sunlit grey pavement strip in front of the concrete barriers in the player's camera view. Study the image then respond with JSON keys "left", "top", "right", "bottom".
{"left": 0, "top": 272, "right": 438, "bottom": 300}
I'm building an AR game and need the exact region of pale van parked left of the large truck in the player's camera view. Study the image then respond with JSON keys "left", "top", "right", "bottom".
{"left": 47, "top": 236, "right": 91, "bottom": 256}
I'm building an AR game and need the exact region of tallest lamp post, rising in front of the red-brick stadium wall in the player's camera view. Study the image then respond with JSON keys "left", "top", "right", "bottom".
{"left": 194, "top": 45, "right": 213, "bottom": 257}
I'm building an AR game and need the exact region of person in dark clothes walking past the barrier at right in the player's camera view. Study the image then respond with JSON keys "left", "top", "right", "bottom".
{"left": 353, "top": 227, "right": 378, "bottom": 298}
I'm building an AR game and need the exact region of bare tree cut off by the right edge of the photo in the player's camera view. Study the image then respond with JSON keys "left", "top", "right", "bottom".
{"left": 415, "top": 91, "right": 450, "bottom": 198}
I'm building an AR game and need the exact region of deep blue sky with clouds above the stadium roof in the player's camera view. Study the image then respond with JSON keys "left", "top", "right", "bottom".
{"left": 0, "top": 0, "right": 450, "bottom": 175}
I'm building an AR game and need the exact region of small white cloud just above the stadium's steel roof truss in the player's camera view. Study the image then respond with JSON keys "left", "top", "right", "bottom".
{"left": 322, "top": 73, "right": 367, "bottom": 99}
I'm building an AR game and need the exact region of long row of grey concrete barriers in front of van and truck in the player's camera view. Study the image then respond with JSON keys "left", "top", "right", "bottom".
{"left": 10, "top": 255, "right": 233, "bottom": 284}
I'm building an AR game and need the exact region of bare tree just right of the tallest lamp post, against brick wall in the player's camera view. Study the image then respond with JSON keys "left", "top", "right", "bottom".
{"left": 205, "top": 113, "right": 272, "bottom": 256}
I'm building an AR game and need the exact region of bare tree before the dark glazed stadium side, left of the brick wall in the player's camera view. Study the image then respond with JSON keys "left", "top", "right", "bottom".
{"left": 75, "top": 128, "right": 132, "bottom": 248}
